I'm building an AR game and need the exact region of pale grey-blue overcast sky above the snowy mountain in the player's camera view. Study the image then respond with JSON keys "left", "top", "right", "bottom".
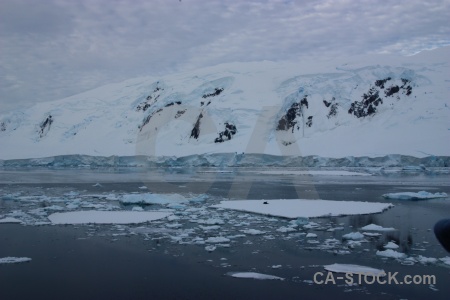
{"left": 0, "top": 0, "right": 450, "bottom": 112}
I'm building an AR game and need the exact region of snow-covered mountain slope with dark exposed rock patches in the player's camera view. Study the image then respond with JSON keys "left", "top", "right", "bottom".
{"left": 0, "top": 47, "right": 450, "bottom": 166}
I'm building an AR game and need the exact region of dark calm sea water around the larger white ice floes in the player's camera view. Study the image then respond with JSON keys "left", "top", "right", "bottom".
{"left": 0, "top": 169, "right": 450, "bottom": 299}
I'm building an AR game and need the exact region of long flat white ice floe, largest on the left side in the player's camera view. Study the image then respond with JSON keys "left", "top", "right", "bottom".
{"left": 48, "top": 210, "right": 172, "bottom": 224}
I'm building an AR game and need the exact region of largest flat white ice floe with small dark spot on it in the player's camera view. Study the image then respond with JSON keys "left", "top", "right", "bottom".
{"left": 211, "top": 199, "right": 393, "bottom": 219}
